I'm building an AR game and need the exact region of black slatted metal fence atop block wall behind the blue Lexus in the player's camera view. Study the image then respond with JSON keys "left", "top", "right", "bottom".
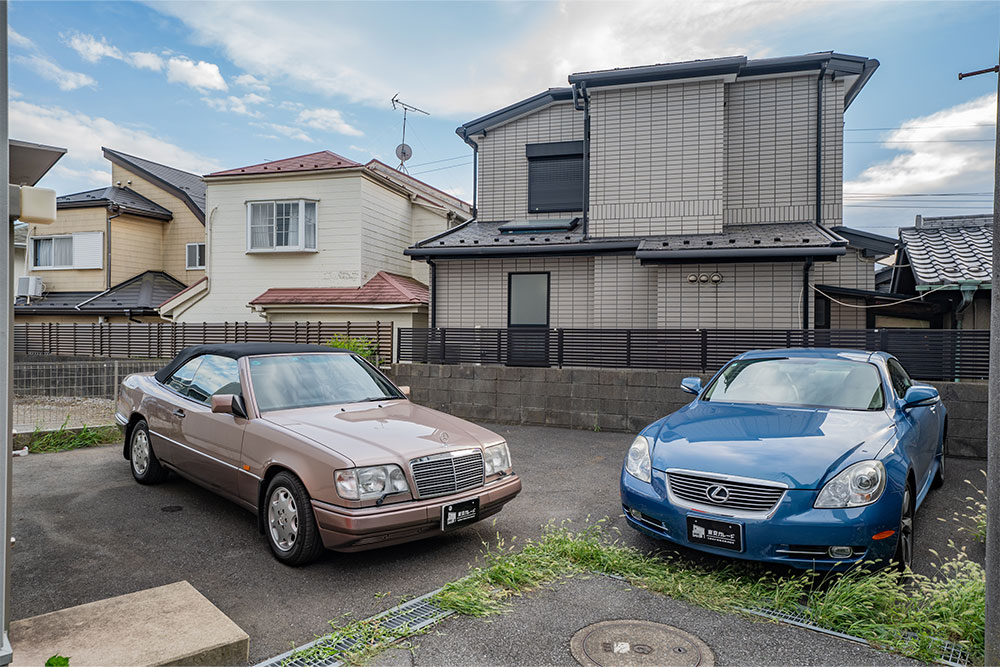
{"left": 396, "top": 328, "right": 990, "bottom": 380}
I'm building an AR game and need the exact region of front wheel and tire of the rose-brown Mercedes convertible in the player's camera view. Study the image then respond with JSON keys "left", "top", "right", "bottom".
{"left": 263, "top": 471, "right": 323, "bottom": 567}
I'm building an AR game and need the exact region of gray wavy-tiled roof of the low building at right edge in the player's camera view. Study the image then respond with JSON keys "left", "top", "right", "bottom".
{"left": 899, "top": 216, "right": 993, "bottom": 285}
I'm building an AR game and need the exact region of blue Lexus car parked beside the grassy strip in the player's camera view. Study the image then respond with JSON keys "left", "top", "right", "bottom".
{"left": 621, "top": 349, "right": 948, "bottom": 569}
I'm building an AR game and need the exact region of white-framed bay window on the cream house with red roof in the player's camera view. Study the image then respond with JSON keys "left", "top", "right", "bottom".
{"left": 247, "top": 199, "right": 316, "bottom": 252}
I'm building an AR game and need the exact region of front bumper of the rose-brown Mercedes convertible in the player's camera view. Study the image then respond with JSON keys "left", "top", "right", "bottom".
{"left": 312, "top": 474, "right": 521, "bottom": 551}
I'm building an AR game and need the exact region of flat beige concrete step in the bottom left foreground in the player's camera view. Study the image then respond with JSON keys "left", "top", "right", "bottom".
{"left": 10, "top": 581, "right": 250, "bottom": 667}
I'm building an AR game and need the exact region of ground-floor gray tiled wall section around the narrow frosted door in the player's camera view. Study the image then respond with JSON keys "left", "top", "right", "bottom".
{"left": 435, "top": 257, "right": 594, "bottom": 329}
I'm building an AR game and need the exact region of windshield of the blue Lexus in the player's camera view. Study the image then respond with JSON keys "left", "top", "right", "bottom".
{"left": 702, "top": 357, "right": 885, "bottom": 410}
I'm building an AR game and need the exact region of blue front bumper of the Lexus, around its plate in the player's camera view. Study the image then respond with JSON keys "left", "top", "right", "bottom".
{"left": 621, "top": 470, "right": 902, "bottom": 570}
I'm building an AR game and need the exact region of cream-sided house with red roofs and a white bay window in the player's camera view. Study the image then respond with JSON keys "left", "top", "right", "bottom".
{"left": 160, "top": 151, "right": 471, "bottom": 327}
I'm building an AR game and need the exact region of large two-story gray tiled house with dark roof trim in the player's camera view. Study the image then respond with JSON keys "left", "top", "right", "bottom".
{"left": 406, "top": 52, "right": 891, "bottom": 329}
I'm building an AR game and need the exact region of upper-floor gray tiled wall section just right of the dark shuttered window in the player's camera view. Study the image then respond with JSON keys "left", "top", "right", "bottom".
{"left": 590, "top": 80, "right": 724, "bottom": 237}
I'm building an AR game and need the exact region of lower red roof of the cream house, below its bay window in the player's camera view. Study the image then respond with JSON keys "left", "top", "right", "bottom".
{"left": 250, "top": 271, "right": 430, "bottom": 306}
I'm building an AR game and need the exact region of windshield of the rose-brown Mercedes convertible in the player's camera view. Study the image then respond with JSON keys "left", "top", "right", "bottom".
{"left": 250, "top": 353, "right": 403, "bottom": 412}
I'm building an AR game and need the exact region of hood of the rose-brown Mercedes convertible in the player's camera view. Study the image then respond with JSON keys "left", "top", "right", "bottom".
{"left": 262, "top": 399, "right": 503, "bottom": 466}
